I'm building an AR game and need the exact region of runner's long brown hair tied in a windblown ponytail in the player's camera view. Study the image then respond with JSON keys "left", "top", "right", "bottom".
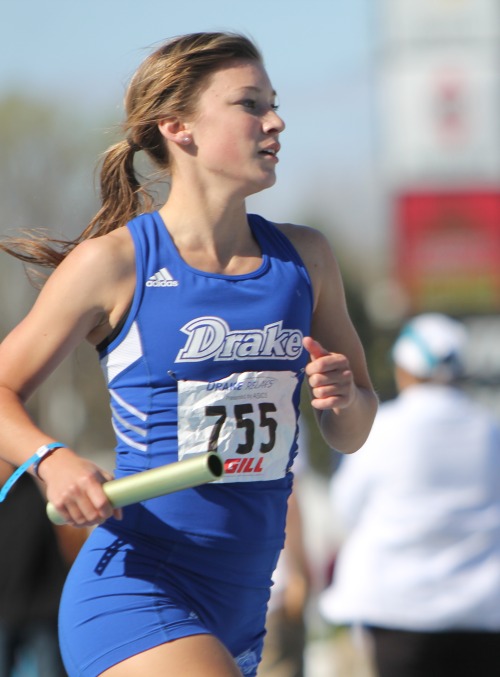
{"left": 0, "top": 33, "right": 262, "bottom": 268}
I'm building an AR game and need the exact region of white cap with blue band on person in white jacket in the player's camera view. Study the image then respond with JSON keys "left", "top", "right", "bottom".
{"left": 392, "top": 313, "right": 467, "bottom": 381}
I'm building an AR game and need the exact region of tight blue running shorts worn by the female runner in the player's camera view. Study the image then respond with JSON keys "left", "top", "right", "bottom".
{"left": 59, "top": 519, "right": 279, "bottom": 677}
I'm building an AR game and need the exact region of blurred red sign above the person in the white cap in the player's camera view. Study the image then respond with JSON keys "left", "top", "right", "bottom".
{"left": 395, "top": 190, "right": 500, "bottom": 315}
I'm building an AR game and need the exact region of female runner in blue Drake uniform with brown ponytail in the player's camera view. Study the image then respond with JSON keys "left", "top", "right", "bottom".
{"left": 0, "top": 33, "right": 377, "bottom": 677}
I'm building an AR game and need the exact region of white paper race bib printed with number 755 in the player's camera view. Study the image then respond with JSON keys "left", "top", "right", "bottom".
{"left": 178, "top": 371, "right": 297, "bottom": 483}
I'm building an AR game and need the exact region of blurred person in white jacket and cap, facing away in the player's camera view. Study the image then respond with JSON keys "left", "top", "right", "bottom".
{"left": 320, "top": 313, "right": 500, "bottom": 677}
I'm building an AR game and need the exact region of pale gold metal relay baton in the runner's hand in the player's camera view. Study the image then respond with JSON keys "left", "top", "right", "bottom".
{"left": 47, "top": 451, "right": 224, "bottom": 524}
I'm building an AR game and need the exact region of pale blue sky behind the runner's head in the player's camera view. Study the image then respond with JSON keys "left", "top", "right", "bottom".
{"left": 0, "top": 0, "right": 384, "bottom": 268}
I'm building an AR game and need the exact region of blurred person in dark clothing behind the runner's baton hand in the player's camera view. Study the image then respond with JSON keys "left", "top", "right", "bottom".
{"left": 0, "top": 461, "right": 85, "bottom": 677}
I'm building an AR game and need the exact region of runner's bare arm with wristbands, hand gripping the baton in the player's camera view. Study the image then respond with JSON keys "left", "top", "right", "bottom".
{"left": 0, "top": 231, "right": 134, "bottom": 525}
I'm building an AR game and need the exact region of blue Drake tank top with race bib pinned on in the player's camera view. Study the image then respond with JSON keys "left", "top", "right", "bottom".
{"left": 99, "top": 212, "right": 312, "bottom": 552}
